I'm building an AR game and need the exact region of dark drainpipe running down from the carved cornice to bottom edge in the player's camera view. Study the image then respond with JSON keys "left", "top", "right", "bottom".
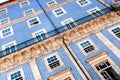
{"left": 63, "top": 38, "right": 90, "bottom": 80}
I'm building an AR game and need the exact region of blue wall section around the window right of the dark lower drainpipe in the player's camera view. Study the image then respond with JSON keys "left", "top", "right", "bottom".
{"left": 70, "top": 34, "right": 120, "bottom": 80}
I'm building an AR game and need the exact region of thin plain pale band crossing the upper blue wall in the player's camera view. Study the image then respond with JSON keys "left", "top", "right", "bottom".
{"left": 0, "top": 0, "right": 73, "bottom": 29}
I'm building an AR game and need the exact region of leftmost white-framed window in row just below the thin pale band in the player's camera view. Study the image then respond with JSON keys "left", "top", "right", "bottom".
{"left": 0, "top": 27, "right": 13, "bottom": 38}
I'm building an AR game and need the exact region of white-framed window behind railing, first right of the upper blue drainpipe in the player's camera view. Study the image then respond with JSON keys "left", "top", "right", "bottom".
{"left": 61, "top": 18, "right": 76, "bottom": 29}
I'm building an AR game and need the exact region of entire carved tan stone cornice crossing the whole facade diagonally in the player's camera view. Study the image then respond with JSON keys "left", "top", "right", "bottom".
{"left": 0, "top": 12, "right": 120, "bottom": 73}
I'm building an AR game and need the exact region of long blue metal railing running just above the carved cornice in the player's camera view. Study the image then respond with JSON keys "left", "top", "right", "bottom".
{"left": 0, "top": 7, "right": 113, "bottom": 58}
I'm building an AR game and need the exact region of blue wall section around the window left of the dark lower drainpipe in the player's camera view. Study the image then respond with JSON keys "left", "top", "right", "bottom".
{"left": 37, "top": 48, "right": 82, "bottom": 80}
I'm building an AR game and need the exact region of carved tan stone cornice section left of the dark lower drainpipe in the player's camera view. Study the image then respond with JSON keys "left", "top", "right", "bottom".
{"left": 0, "top": 35, "right": 63, "bottom": 73}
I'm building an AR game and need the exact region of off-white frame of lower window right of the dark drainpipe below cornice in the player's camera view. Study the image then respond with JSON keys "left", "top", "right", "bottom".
{"left": 77, "top": 38, "right": 99, "bottom": 56}
